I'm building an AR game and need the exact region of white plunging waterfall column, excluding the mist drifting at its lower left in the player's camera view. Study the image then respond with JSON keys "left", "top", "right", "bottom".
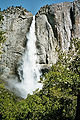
{"left": 22, "top": 16, "right": 41, "bottom": 97}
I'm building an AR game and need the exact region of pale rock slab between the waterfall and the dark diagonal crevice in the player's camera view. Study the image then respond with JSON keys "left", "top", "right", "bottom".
{"left": 36, "top": 14, "right": 57, "bottom": 64}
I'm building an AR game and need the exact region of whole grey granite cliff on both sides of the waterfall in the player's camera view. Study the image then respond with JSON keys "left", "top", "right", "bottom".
{"left": 0, "top": 1, "right": 80, "bottom": 81}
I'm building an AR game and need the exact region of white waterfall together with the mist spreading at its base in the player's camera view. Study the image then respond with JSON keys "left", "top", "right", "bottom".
{"left": 6, "top": 16, "right": 42, "bottom": 98}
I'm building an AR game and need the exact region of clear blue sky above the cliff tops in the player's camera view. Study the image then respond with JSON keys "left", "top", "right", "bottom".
{"left": 0, "top": 0, "right": 73, "bottom": 14}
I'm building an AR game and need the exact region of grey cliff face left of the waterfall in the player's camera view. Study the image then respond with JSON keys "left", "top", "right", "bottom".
{"left": 0, "top": 7, "right": 33, "bottom": 78}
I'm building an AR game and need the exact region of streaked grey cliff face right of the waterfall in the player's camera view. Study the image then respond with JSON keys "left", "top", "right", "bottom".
{"left": 36, "top": 1, "right": 80, "bottom": 64}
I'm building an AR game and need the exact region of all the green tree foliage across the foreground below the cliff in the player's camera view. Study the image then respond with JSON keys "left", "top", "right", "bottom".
{"left": 0, "top": 39, "right": 80, "bottom": 120}
